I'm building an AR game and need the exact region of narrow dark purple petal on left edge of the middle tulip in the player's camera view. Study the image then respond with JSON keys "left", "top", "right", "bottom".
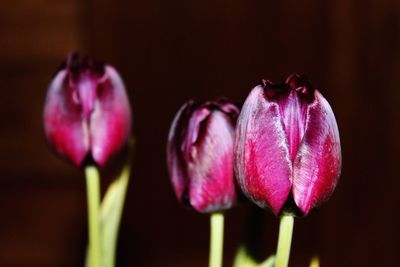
{"left": 167, "top": 101, "right": 193, "bottom": 201}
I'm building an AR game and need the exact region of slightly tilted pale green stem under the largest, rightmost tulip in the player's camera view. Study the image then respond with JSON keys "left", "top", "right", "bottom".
{"left": 275, "top": 215, "right": 294, "bottom": 267}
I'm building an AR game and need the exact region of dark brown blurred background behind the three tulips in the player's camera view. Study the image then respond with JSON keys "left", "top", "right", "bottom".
{"left": 0, "top": 0, "right": 400, "bottom": 267}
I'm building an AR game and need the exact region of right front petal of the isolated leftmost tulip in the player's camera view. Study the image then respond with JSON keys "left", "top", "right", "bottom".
{"left": 90, "top": 65, "right": 131, "bottom": 166}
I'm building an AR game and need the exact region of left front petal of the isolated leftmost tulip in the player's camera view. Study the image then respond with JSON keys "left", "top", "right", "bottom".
{"left": 43, "top": 70, "right": 89, "bottom": 166}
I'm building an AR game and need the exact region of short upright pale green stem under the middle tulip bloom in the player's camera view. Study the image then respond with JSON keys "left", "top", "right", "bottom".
{"left": 208, "top": 212, "right": 224, "bottom": 267}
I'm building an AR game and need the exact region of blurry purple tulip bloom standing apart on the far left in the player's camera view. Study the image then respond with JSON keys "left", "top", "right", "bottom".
{"left": 43, "top": 53, "right": 131, "bottom": 166}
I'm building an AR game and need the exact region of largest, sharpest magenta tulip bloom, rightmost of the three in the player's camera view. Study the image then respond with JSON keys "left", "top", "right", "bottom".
{"left": 235, "top": 74, "right": 341, "bottom": 215}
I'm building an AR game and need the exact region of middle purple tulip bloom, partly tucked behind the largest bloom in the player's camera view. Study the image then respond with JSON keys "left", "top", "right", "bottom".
{"left": 167, "top": 100, "right": 239, "bottom": 213}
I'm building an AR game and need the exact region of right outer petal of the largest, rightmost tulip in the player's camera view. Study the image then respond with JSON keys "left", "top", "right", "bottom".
{"left": 293, "top": 91, "right": 341, "bottom": 215}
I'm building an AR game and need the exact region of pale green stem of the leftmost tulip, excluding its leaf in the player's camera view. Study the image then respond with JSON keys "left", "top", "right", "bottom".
{"left": 85, "top": 166, "right": 101, "bottom": 267}
